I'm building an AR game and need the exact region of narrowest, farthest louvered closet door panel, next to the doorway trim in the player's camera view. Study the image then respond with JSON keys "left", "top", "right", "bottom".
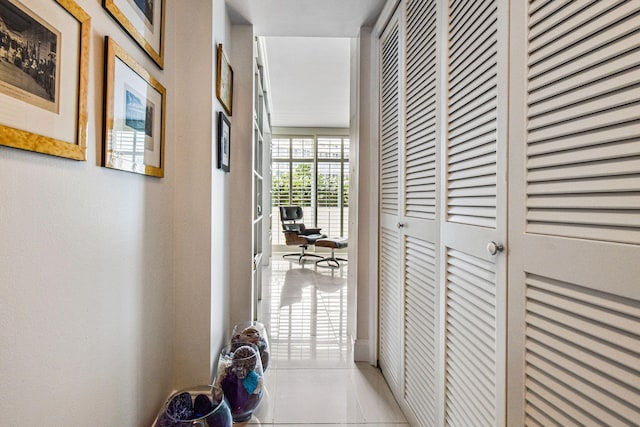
{"left": 378, "top": 6, "right": 403, "bottom": 393}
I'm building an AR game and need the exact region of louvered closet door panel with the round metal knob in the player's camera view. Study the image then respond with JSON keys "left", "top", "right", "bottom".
{"left": 439, "top": 0, "right": 508, "bottom": 427}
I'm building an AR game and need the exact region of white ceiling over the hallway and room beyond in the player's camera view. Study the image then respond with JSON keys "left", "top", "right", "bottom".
{"left": 227, "top": 0, "right": 385, "bottom": 128}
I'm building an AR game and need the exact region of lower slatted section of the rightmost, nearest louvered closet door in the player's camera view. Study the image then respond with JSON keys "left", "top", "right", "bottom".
{"left": 526, "top": 275, "right": 640, "bottom": 425}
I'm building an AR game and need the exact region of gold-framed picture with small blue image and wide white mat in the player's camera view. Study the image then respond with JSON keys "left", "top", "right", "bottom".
{"left": 102, "top": 37, "right": 166, "bottom": 178}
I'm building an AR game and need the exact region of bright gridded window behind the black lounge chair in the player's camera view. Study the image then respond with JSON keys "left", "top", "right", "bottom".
{"left": 271, "top": 136, "right": 349, "bottom": 245}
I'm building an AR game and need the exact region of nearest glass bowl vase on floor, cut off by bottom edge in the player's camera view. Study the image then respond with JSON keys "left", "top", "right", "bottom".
{"left": 153, "top": 385, "right": 233, "bottom": 427}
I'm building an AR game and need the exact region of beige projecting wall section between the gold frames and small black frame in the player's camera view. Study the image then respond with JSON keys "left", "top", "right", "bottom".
{"left": 174, "top": 0, "right": 229, "bottom": 388}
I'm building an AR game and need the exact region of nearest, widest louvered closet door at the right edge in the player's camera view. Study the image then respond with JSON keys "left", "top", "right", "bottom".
{"left": 509, "top": 0, "right": 640, "bottom": 426}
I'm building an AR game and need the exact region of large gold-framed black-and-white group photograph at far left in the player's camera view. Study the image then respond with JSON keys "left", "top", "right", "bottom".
{"left": 0, "top": 0, "right": 91, "bottom": 160}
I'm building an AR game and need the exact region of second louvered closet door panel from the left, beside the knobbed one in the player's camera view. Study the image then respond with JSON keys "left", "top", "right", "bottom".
{"left": 400, "top": 0, "right": 441, "bottom": 426}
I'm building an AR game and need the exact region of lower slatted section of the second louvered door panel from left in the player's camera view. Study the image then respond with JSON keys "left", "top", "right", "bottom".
{"left": 404, "top": 237, "right": 437, "bottom": 426}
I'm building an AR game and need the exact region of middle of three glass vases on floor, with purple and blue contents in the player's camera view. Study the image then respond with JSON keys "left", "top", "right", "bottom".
{"left": 215, "top": 344, "right": 264, "bottom": 422}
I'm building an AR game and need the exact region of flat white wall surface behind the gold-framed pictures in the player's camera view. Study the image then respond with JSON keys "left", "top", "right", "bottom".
{"left": 0, "top": 0, "right": 176, "bottom": 426}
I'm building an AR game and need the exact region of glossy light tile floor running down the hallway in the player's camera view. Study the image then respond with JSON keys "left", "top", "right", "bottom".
{"left": 238, "top": 254, "right": 408, "bottom": 427}
